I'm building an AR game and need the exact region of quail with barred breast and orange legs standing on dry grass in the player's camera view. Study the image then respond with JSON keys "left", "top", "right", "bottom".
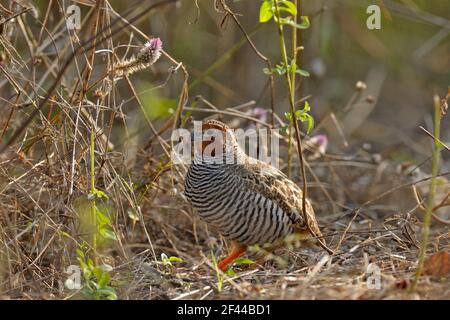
{"left": 184, "top": 120, "right": 326, "bottom": 270}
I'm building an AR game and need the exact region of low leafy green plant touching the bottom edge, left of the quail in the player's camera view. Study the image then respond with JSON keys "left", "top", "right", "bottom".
{"left": 73, "top": 245, "right": 117, "bottom": 300}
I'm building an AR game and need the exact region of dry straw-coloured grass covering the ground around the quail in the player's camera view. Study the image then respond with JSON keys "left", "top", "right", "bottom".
{"left": 0, "top": 1, "right": 450, "bottom": 299}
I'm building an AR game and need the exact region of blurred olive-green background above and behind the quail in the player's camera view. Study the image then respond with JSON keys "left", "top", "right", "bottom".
{"left": 6, "top": 0, "right": 450, "bottom": 164}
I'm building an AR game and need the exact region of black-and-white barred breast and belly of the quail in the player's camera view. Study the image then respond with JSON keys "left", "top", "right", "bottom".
{"left": 185, "top": 163, "right": 296, "bottom": 245}
